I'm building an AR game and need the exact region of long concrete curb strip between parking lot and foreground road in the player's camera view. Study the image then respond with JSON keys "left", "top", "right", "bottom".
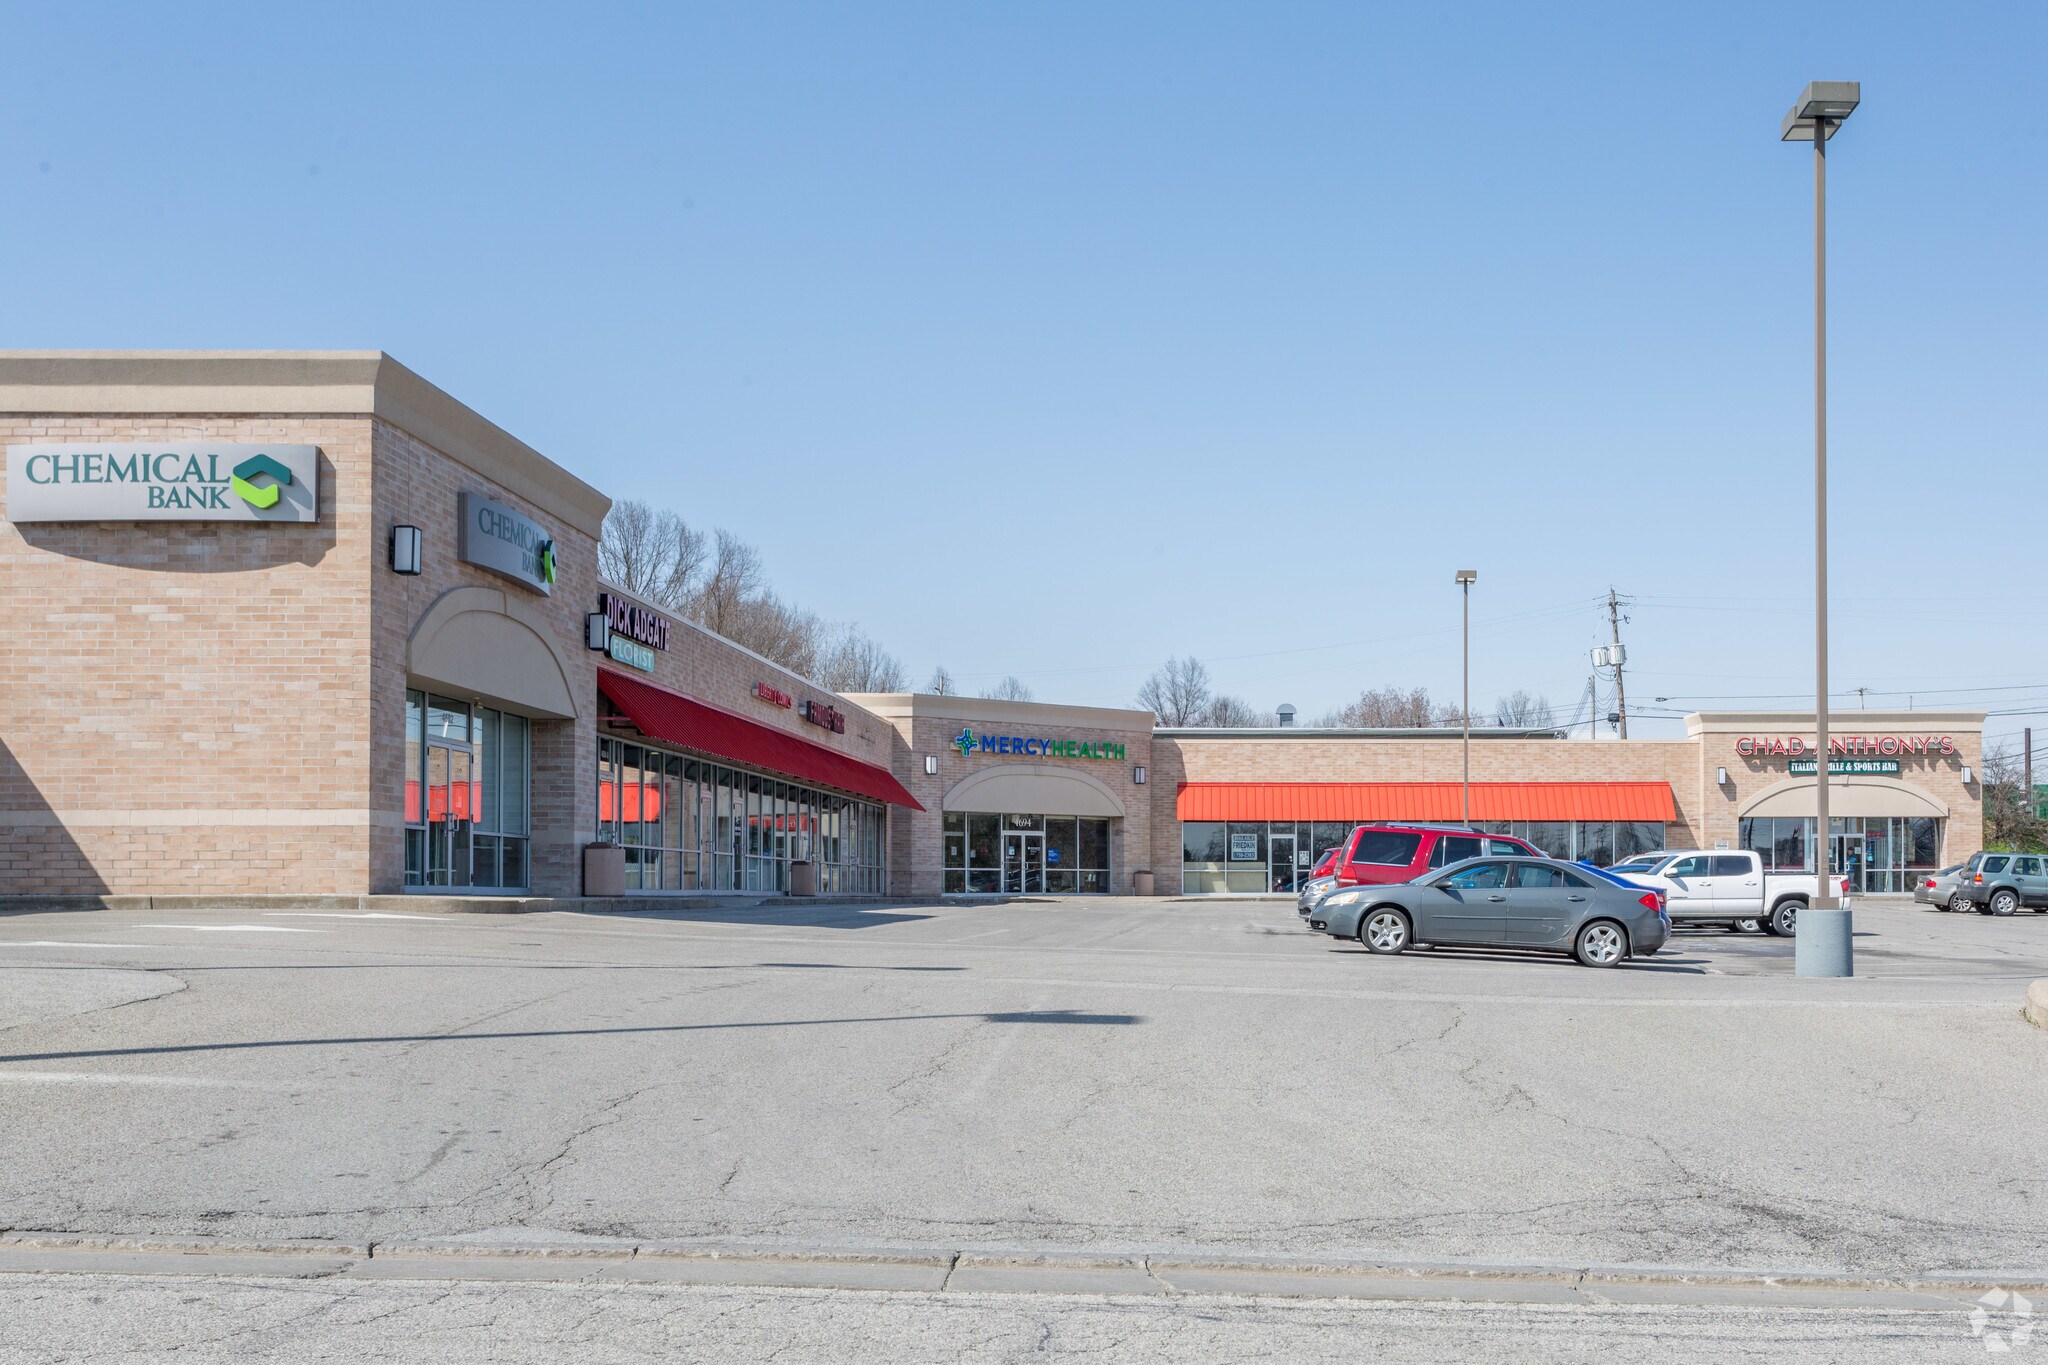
{"left": 0, "top": 1232, "right": 2048, "bottom": 1310}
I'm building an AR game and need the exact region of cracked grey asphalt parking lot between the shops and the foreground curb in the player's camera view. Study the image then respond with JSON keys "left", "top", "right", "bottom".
{"left": 0, "top": 900, "right": 2048, "bottom": 1359}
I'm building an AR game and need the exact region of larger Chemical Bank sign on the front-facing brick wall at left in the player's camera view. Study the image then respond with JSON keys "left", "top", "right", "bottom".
{"left": 6, "top": 444, "right": 319, "bottom": 522}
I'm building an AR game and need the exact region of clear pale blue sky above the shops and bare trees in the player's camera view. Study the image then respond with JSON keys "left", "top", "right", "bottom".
{"left": 0, "top": 2, "right": 2048, "bottom": 749}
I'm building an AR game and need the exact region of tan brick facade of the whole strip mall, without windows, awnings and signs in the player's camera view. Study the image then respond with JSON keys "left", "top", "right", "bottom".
{"left": 0, "top": 352, "right": 1985, "bottom": 896}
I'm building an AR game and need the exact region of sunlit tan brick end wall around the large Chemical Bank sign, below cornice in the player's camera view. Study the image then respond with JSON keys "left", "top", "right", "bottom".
{"left": 0, "top": 413, "right": 371, "bottom": 894}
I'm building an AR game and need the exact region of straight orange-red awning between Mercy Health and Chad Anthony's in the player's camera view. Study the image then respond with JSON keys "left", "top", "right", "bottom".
{"left": 1176, "top": 782, "right": 1677, "bottom": 825}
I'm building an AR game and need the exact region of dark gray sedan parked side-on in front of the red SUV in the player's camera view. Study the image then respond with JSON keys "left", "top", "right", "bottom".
{"left": 1309, "top": 857, "right": 1671, "bottom": 966}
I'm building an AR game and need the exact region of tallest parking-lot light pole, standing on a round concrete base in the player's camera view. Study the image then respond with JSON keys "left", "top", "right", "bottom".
{"left": 1782, "top": 80, "right": 1864, "bottom": 976}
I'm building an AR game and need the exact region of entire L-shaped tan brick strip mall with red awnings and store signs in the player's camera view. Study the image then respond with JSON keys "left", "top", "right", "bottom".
{"left": 0, "top": 352, "right": 1985, "bottom": 900}
